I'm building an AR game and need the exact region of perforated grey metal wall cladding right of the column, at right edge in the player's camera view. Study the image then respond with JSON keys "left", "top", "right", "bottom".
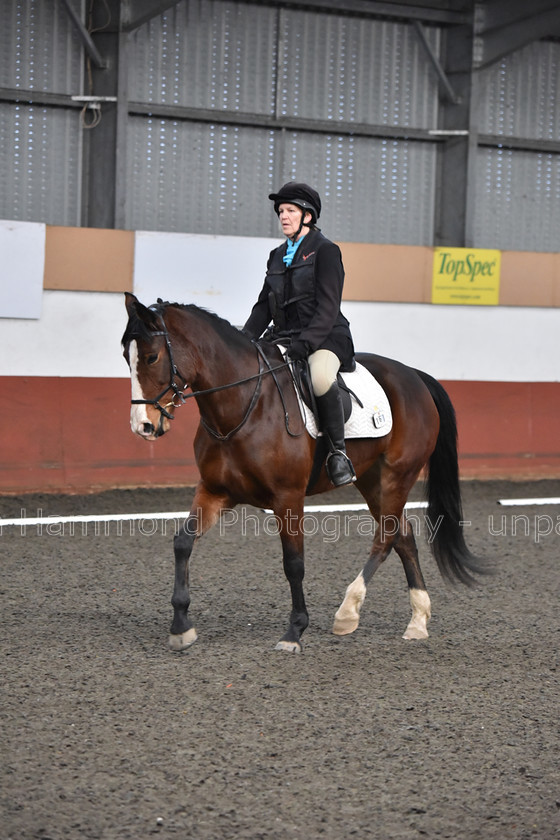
{"left": 474, "top": 41, "right": 560, "bottom": 251}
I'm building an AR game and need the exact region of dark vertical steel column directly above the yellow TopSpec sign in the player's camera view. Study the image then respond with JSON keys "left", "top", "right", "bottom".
{"left": 434, "top": 11, "right": 477, "bottom": 247}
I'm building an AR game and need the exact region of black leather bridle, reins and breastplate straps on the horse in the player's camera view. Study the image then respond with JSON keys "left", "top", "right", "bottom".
{"left": 130, "top": 307, "right": 303, "bottom": 441}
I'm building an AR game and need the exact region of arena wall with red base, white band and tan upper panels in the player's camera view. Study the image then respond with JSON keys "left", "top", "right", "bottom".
{"left": 0, "top": 222, "right": 560, "bottom": 493}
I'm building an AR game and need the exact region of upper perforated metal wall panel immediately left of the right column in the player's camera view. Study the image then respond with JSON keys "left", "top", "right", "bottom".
{"left": 280, "top": 11, "right": 439, "bottom": 128}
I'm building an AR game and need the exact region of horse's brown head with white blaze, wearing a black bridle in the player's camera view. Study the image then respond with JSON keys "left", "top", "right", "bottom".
{"left": 122, "top": 292, "right": 186, "bottom": 440}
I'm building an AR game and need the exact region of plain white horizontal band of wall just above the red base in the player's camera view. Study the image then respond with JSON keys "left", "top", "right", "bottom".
{"left": 0, "top": 288, "right": 560, "bottom": 382}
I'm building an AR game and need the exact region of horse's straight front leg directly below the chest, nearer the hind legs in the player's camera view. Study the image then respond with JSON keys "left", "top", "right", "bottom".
{"left": 276, "top": 501, "right": 309, "bottom": 653}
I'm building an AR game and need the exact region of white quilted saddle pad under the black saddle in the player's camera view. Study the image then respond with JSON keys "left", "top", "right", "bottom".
{"left": 298, "top": 364, "right": 393, "bottom": 438}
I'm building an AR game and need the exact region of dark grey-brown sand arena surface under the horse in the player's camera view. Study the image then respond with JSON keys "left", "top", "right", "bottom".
{"left": 0, "top": 481, "right": 560, "bottom": 840}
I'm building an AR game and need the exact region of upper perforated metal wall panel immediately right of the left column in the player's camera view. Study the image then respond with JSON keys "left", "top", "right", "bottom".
{"left": 129, "top": 0, "right": 277, "bottom": 114}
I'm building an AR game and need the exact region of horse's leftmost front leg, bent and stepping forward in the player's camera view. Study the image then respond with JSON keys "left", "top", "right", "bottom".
{"left": 169, "top": 485, "right": 233, "bottom": 651}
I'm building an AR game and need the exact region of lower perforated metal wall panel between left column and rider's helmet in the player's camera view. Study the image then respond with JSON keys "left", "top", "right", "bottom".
{"left": 127, "top": 117, "right": 277, "bottom": 236}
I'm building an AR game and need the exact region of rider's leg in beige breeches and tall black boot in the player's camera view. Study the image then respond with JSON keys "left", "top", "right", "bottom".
{"left": 309, "top": 349, "right": 356, "bottom": 487}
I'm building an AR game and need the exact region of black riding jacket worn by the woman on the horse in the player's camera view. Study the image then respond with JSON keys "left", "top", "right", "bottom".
{"left": 243, "top": 230, "right": 354, "bottom": 368}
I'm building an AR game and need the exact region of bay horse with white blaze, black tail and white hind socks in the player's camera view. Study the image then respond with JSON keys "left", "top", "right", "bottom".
{"left": 122, "top": 292, "right": 485, "bottom": 653}
